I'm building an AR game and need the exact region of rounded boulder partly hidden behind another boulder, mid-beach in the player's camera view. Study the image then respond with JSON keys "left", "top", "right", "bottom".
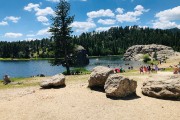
{"left": 88, "top": 66, "right": 114, "bottom": 87}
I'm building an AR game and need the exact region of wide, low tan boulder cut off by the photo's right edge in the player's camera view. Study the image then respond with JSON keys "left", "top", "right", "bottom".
{"left": 141, "top": 76, "right": 180, "bottom": 99}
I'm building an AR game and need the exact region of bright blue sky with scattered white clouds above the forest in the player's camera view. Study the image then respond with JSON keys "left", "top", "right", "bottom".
{"left": 0, "top": 0, "right": 180, "bottom": 41}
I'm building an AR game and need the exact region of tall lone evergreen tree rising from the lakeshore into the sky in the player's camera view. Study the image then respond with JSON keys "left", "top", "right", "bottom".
{"left": 50, "top": 0, "right": 74, "bottom": 74}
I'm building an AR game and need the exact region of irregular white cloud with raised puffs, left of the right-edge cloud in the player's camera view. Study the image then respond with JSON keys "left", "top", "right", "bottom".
{"left": 116, "top": 5, "right": 149, "bottom": 23}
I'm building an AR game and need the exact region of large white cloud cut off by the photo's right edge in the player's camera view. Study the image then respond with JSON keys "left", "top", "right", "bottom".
{"left": 152, "top": 6, "right": 180, "bottom": 29}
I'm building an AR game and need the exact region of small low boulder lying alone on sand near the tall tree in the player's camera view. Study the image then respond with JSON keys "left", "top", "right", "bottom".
{"left": 40, "top": 74, "right": 65, "bottom": 88}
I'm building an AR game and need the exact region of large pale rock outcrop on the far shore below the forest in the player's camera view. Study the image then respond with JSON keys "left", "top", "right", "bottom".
{"left": 124, "top": 44, "right": 174, "bottom": 61}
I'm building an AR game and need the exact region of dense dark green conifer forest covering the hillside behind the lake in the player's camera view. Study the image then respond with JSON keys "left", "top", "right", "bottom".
{"left": 0, "top": 25, "right": 180, "bottom": 58}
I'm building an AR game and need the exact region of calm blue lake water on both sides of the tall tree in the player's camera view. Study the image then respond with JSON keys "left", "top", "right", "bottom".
{"left": 0, "top": 56, "right": 146, "bottom": 79}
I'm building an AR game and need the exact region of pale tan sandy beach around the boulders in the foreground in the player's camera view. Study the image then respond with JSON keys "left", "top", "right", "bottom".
{"left": 0, "top": 53, "right": 180, "bottom": 120}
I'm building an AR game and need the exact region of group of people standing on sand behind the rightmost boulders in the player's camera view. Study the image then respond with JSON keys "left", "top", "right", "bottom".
{"left": 139, "top": 65, "right": 159, "bottom": 74}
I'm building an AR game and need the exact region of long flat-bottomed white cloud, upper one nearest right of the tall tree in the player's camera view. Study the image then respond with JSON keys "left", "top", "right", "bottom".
{"left": 87, "top": 9, "right": 115, "bottom": 18}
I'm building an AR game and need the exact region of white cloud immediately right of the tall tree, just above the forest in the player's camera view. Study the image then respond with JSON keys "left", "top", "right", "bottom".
{"left": 71, "top": 21, "right": 96, "bottom": 32}
